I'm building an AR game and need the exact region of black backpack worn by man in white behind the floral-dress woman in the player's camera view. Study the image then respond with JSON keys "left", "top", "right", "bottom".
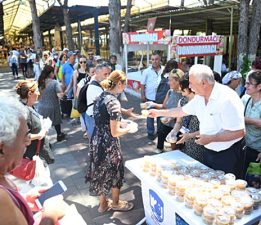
{"left": 77, "top": 80, "right": 100, "bottom": 113}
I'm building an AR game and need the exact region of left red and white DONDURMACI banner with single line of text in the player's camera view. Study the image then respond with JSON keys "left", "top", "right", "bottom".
{"left": 122, "top": 30, "right": 171, "bottom": 45}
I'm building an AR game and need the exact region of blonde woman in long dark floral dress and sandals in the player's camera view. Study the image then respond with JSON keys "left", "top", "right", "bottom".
{"left": 86, "top": 70, "right": 133, "bottom": 213}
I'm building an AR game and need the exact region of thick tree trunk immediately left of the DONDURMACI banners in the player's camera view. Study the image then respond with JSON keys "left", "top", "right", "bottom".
{"left": 109, "top": 0, "right": 121, "bottom": 59}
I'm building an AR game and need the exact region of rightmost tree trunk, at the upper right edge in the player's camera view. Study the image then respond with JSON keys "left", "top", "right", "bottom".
{"left": 248, "top": 0, "right": 261, "bottom": 62}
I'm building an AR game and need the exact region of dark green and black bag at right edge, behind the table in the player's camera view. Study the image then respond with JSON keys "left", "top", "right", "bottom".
{"left": 246, "top": 162, "right": 261, "bottom": 189}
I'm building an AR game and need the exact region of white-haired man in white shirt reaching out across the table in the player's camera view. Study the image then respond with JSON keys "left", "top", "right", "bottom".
{"left": 150, "top": 64, "right": 245, "bottom": 178}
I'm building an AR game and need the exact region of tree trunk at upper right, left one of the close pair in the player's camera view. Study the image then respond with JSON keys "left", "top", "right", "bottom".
{"left": 237, "top": 0, "right": 249, "bottom": 71}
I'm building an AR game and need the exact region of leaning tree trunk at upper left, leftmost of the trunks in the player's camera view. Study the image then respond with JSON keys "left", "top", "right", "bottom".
{"left": 29, "top": 0, "right": 42, "bottom": 49}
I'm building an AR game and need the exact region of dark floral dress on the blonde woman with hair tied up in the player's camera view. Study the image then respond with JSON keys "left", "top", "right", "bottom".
{"left": 86, "top": 91, "right": 124, "bottom": 195}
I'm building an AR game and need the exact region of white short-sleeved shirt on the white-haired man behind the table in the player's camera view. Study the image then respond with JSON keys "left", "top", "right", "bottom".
{"left": 182, "top": 82, "right": 245, "bottom": 152}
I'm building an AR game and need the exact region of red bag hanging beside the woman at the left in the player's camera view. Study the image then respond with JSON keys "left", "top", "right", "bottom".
{"left": 10, "top": 158, "right": 36, "bottom": 180}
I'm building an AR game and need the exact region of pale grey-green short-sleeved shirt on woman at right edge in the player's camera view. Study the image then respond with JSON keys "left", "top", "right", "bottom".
{"left": 242, "top": 95, "right": 261, "bottom": 152}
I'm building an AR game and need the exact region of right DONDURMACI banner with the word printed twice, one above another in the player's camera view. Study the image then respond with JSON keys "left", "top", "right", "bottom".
{"left": 172, "top": 35, "right": 224, "bottom": 57}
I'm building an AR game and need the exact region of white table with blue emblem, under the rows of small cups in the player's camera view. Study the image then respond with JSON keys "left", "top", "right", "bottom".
{"left": 125, "top": 151, "right": 261, "bottom": 225}
